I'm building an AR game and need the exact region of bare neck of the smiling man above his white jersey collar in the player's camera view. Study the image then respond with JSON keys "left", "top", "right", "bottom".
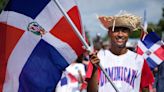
{"left": 109, "top": 46, "right": 127, "bottom": 55}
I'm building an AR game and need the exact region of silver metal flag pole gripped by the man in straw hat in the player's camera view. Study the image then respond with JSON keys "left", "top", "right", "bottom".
{"left": 53, "top": 0, "right": 119, "bottom": 92}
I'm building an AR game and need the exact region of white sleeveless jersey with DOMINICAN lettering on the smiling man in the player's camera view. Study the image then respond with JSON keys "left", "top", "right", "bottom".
{"left": 98, "top": 50, "right": 144, "bottom": 92}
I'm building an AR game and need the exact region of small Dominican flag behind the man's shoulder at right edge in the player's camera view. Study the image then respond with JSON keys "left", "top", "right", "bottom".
{"left": 137, "top": 32, "right": 164, "bottom": 69}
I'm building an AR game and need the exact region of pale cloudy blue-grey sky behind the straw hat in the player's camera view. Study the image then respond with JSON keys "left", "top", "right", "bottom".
{"left": 76, "top": 0, "right": 164, "bottom": 38}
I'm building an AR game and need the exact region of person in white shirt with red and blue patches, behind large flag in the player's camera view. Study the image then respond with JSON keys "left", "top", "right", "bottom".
{"left": 55, "top": 55, "right": 86, "bottom": 92}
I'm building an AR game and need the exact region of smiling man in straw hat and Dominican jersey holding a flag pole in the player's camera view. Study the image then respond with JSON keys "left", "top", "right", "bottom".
{"left": 87, "top": 12, "right": 154, "bottom": 92}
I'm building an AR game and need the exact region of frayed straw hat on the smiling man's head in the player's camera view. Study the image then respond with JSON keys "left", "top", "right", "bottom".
{"left": 98, "top": 11, "right": 141, "bottom": 31}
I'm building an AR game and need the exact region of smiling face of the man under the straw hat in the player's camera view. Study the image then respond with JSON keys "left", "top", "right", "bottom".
{"left": 109, "top": 27, "right": 130, "bottom": 48}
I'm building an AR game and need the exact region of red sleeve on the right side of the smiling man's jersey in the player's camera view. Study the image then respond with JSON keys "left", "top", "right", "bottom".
{"left": 140, "top": 61, "right": 154, "bottom": 89}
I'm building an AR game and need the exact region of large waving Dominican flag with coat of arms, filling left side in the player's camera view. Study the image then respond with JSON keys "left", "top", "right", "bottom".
{"left": 0, "top": 0, "right": 84, "bottom": 92}
